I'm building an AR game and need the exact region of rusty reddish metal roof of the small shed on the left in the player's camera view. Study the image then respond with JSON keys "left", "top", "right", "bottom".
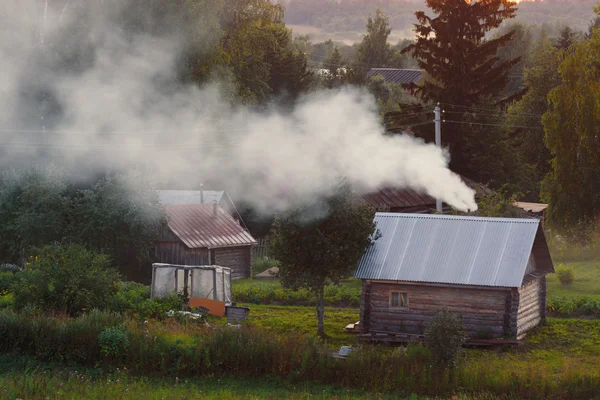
{"left": 165, "top": 204, "right": 256, "bottom": 249}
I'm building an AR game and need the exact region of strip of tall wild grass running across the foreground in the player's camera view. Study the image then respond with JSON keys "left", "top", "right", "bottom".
{"left": 0, "top": 311, "right": 600, "bottom": 399}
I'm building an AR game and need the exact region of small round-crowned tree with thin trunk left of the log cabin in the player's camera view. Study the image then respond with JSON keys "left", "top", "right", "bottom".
{"left": 271, "top": 184, "right": 376, "bottom": 335}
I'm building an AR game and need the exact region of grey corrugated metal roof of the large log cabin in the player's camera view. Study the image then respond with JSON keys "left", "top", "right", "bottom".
{"left": 356, "top": 213, "right": 543, "bottom": 287}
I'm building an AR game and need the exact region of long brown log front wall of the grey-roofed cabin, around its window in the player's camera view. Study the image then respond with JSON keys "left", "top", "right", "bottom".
{"left": 361, "top": 281, "right": 512, "bottom": 337}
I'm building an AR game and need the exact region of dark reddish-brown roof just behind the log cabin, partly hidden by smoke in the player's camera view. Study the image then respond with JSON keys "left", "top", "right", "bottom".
{"left": 362, "top": 176, "right": 491, "bottom": 210}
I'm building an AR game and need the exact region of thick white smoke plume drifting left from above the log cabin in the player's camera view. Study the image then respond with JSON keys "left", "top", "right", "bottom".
{"left": 0, "top": 0, "right": 477, "bottom": 211}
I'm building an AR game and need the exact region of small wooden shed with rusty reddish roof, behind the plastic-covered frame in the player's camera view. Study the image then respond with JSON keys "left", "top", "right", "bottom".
{"left": 155, "top": 203, "right": 256, "bottom": 279}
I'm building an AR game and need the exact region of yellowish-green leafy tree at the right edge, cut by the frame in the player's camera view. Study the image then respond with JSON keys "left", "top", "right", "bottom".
{"left": 542, "top": 25, "right": 600, "bottom": 229}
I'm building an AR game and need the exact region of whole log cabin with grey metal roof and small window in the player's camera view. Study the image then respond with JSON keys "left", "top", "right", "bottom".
{"left": 355, "top": 213, "right": 554, "bottom": 339}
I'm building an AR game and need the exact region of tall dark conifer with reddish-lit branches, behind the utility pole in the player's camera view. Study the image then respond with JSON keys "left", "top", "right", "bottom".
{"left": 403, "top": 0, "right": 520, "bottom": 179}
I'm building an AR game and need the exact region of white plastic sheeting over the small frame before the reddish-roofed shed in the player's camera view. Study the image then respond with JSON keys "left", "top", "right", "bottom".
{"left": 152, "top": 264, "right": 231, "bottom": 305}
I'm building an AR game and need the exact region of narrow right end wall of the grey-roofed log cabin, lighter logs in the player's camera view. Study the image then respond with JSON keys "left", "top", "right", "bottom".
{"left": 517, "top": 277, "right": 546, "bottom": 339}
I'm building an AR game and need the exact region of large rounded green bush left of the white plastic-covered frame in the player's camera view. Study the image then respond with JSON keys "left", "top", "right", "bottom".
{"left": 14, "top": 245, "right": 119, "bottom": 315}
